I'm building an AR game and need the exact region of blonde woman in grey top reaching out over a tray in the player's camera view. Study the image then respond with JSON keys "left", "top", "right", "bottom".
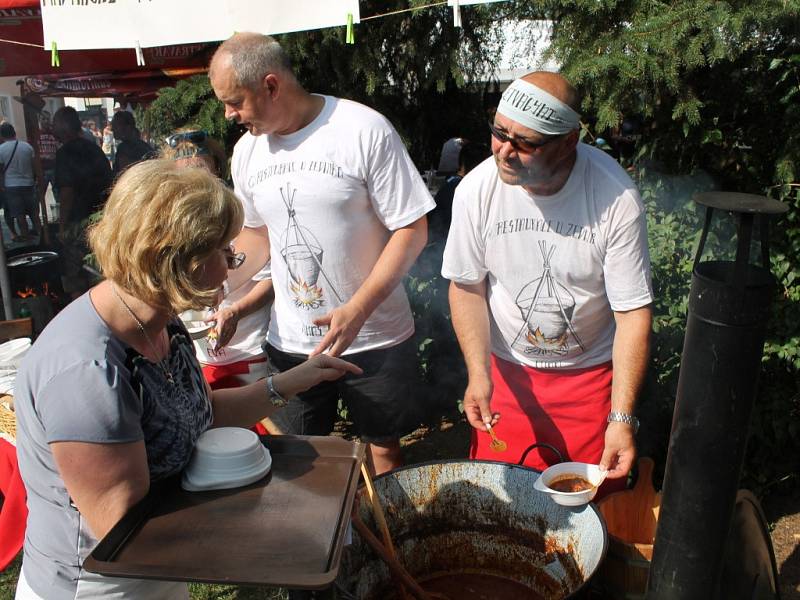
{"left": 10, "top": 161, "right": 359, "bottom": 600}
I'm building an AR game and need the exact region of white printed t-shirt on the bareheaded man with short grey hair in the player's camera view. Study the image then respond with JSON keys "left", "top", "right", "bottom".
{"left": 231, "top": 96, "right": 435, "bottom": 354}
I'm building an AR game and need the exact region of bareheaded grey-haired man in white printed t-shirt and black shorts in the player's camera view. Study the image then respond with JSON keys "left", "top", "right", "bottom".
{"left": 209, "top": 33, "right": 434, "bottom": 473}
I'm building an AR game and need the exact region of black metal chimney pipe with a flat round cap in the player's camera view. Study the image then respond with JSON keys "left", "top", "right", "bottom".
{"left": 646, "top": 192, "right": 787, "bottom": 600}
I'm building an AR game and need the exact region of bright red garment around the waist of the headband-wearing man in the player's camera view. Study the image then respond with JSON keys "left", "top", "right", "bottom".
{"left": 470, "top": 355, "right": 626, "bottom": 494}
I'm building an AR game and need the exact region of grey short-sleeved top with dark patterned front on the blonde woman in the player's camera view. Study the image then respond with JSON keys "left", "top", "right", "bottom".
{"left": 15, "top": 293, "right": 212, "bottom": 600}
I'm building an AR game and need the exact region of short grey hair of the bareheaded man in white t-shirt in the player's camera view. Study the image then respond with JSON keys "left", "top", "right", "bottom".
{"left": 212, "top": 32, "right": 294, "bottom": 90}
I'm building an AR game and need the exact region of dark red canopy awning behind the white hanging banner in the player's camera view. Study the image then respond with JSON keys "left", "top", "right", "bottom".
{"left": 0, "top": 0, "right": 216, "bottom": 99}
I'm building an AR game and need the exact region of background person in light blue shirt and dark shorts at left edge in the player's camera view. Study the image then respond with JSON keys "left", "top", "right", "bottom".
{"left": 0, "top": 123, "right": 44, "bottom": 240}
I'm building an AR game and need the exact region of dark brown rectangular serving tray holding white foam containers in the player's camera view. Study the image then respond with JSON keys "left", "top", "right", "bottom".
{"left": 83, "top": 435, "right": 365, "bottom": 589}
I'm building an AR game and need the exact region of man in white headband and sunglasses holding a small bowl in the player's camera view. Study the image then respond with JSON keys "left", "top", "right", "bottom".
{"left": 442, "top": 72, "right": 653, "bottom": 493}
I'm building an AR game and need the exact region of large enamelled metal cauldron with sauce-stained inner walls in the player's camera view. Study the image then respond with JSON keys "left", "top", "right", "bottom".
{"left": 337, "top": 461, "right": 607, "bottom": 600}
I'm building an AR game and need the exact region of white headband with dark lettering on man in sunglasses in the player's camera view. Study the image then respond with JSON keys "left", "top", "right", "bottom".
{"left": 497, "top": 79, "right": 581, "bottom": 135}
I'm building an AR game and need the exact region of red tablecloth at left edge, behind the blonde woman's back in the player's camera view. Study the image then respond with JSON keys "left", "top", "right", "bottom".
{"left": 0, "top": 438, "right": 28, "bottom": 571}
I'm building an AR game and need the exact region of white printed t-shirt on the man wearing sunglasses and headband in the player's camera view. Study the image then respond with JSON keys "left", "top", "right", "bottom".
{"left": 442, "top": 144, "right": 653, "bottom": 368}
